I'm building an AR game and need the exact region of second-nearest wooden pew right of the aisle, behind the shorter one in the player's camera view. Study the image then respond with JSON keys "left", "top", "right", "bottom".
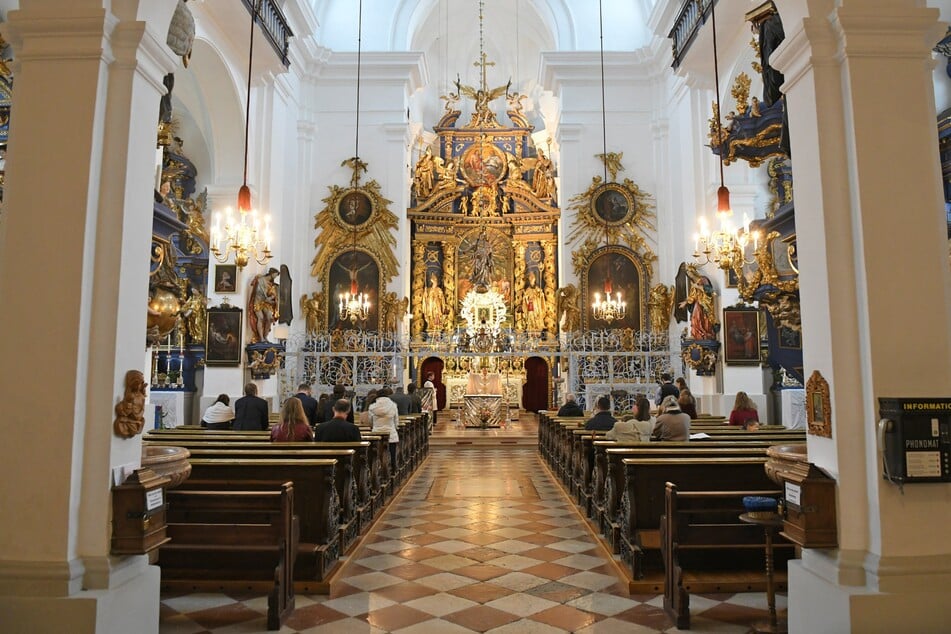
{"left": 618, "top": 457, "right": 774, "bottom": 592}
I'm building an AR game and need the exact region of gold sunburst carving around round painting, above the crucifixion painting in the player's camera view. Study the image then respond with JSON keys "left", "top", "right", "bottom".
{"left": 310, "top": 179, "right": 399, "bottom": 287}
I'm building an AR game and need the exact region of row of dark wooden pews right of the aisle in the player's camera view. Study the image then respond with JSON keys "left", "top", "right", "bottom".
{"left": 538, "top": 413, "right": 805, "bottom": 624}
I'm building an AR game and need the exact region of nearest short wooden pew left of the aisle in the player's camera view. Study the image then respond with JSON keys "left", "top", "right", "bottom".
{"left": 159, "top": 482, "right": 299, "bottom": 630}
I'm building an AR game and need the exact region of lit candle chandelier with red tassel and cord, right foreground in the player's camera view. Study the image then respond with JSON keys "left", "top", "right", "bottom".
{"left": 693, "top": 2, "right": 759, "bottom": 271}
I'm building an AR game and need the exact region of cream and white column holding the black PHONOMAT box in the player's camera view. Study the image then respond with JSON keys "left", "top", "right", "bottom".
{"left": 774, "top": 0, "right": 951, "bottom": 632}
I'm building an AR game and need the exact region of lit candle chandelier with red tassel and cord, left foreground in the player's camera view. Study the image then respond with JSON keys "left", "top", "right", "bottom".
{"left": 209, "top": 0, "right": 271, "bottom": 269}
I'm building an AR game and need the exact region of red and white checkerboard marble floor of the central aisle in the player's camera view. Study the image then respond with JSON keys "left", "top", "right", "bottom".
{"left": 159, "top": 447, "right": 786, "bottom": 634}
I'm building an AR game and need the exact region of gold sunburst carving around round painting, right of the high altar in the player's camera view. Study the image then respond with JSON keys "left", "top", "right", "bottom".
{"left": 568, "top": 176, "right": 657, "bottom": 264}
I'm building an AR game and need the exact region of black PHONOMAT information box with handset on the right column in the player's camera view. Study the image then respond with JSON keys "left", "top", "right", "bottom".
{"left": 878, "top": 398, "right": 951, "bottom": 485}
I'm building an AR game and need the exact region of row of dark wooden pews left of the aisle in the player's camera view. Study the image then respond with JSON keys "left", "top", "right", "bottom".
{"left": 145, "top": 415, "right": 429, "bottom": 604}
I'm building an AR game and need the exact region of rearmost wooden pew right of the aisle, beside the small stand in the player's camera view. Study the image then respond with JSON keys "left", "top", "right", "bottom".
{"left": 661, "top": 482, "right": 795, "bottom": 630}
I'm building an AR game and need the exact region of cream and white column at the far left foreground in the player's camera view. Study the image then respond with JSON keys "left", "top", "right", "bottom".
{"left": 0, "top": 0, "right": 176, "bottom": 632}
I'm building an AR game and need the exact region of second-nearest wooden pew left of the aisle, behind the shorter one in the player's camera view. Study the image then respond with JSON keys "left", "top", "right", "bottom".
{"left": 182, "top": 457, "right": 340, "bottom": 593}
